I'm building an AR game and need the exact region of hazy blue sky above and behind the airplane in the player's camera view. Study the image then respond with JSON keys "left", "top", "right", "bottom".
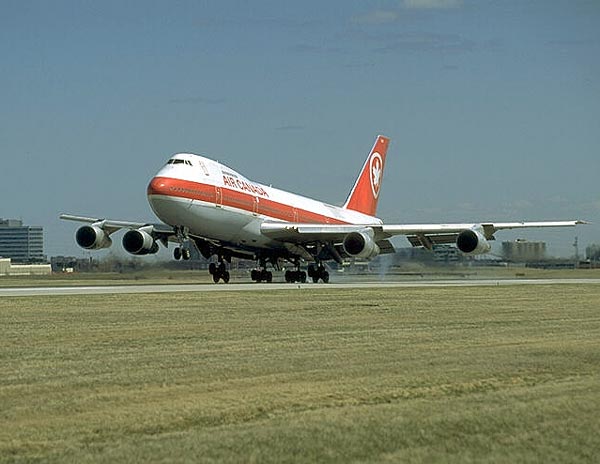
{"left": 0, "top": 0, "right": 600, "bottom": 256}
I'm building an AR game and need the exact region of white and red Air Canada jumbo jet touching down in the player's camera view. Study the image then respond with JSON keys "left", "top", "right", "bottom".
{"left": 60, "top": 135, "right": 585, "bottom": 283}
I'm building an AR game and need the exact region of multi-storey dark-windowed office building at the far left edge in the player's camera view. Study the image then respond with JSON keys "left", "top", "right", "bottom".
{"left": 0, "top": 218, "right": 45, "bottom": 263}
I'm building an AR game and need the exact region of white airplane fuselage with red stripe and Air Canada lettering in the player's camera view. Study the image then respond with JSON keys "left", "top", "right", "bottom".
{"left": 148, "top": 153, "right": 382, "bottom": 254}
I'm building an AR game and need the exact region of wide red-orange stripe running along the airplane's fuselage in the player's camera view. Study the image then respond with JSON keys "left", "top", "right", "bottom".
{"left": 148, "top": 177, "right": 347, "bottom": 224}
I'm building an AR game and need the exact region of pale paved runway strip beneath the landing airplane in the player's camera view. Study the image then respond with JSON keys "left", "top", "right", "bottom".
{"left": 0, "top": 279, "right": 600, "bottom": 297}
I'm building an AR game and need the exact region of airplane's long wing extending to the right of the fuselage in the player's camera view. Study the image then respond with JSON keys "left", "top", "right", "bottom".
{"left": 261, "top": 220, "right": 586, "bottom": 249}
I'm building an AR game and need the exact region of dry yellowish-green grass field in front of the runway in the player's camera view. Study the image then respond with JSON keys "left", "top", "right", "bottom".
{"left": 0, "top": 285, "right": 600, "bottom": 463}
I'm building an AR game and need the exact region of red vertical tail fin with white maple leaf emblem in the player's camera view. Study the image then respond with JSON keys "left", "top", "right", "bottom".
{"left": 344, "top": 135, "right": 390, "bottom": 216}
